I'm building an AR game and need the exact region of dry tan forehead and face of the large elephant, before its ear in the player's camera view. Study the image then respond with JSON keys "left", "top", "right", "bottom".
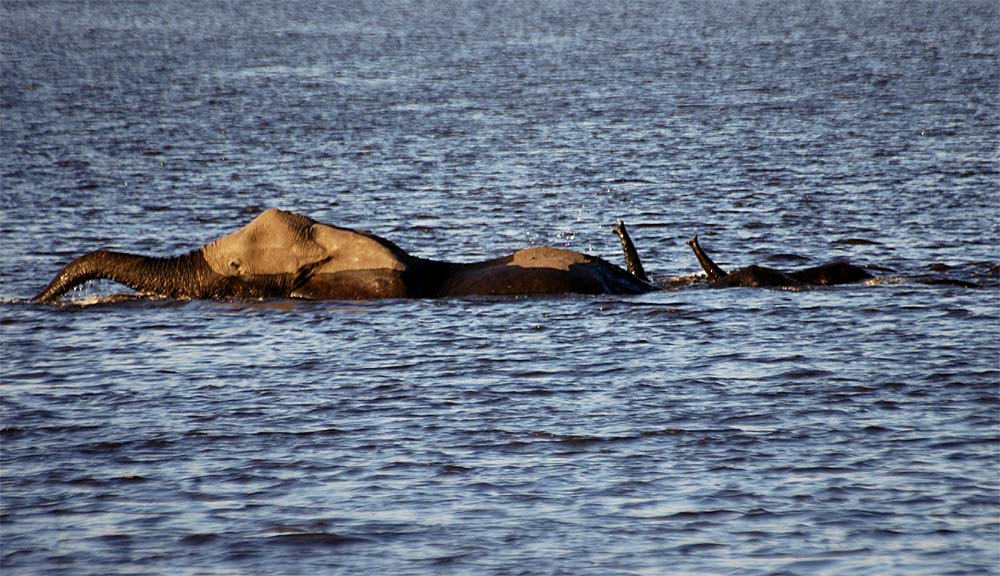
{"left": 202, "top": 208, "right": 329, "bottom": 276}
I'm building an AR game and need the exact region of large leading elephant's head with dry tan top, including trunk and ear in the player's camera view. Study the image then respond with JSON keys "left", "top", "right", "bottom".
{"left": 33, "top": 209, "right": 412, "bottom": 302}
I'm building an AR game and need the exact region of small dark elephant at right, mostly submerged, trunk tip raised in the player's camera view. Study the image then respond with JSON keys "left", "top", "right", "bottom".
{"left": 688, "top": 236, "right": 874, "bottom": 288}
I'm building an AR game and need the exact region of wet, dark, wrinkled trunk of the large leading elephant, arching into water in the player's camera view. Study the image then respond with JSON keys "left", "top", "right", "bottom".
{"left": 32, "top": 250, "right": 214, "bottom": 302}
